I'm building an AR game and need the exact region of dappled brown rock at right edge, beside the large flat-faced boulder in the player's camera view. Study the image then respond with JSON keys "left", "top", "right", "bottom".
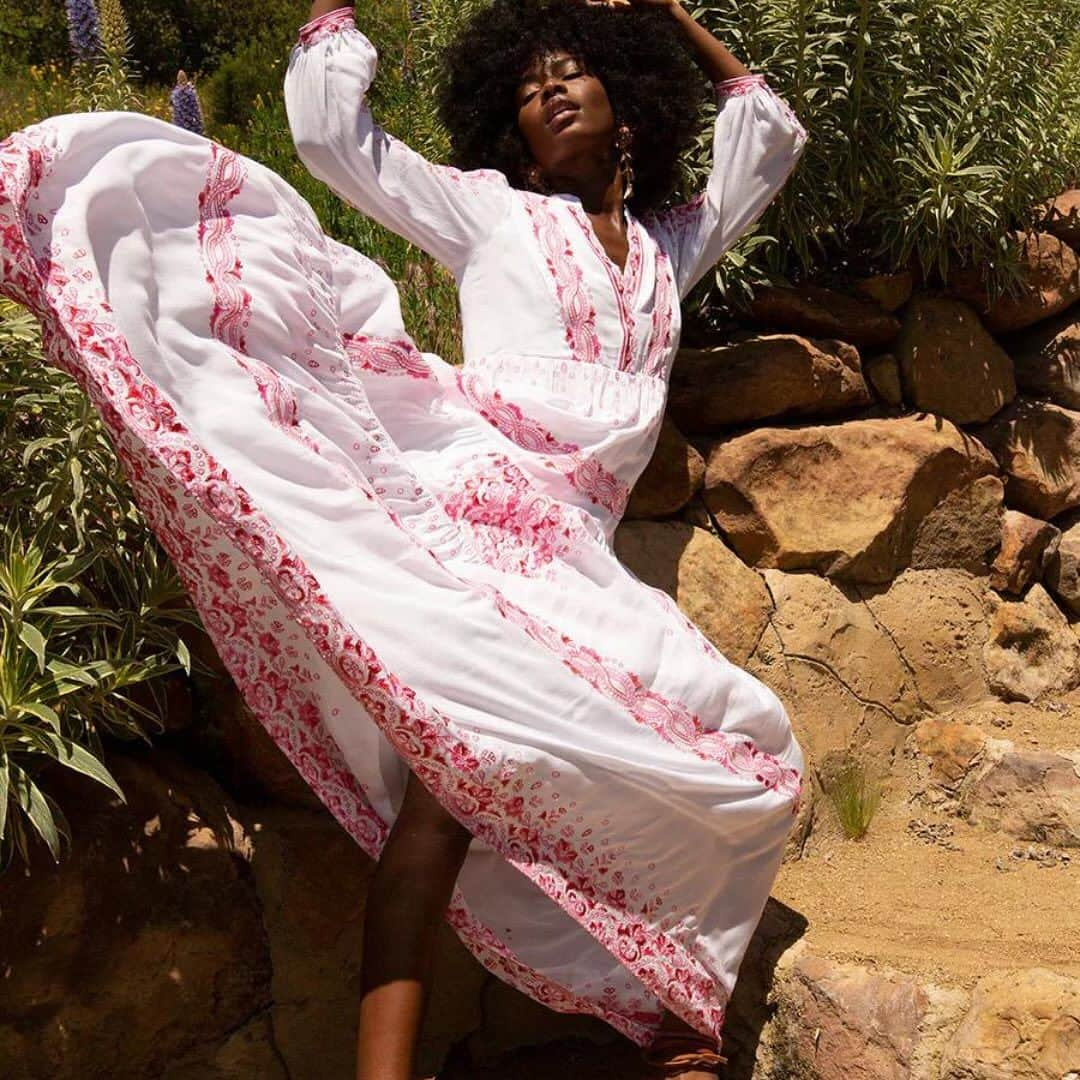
{"left": 972, "top": 397, "right": 1080, "bottom": 521}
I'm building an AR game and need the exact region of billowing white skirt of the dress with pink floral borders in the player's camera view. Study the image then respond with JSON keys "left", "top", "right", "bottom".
{"left": 0, "top": 112, "right": 804, "bottom": 1045}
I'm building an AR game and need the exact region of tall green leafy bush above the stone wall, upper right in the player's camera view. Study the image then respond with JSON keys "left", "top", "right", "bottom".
{"left": 691, "top": 0, "right": 1080, "bottom": 308}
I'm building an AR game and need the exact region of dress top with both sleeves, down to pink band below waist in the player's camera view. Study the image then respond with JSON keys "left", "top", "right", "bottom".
{"left": 285, "top": 8, "right": 806, "bottom": 538}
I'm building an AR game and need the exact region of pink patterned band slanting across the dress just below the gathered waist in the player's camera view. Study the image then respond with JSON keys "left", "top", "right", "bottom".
{"left": 456, "top": 368, "right": 630, "bottom": 517}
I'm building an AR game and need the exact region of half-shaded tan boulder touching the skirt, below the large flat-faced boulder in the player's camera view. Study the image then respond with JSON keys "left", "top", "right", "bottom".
{"left": 615, "top": 522, "right": 772, "bottom": 666}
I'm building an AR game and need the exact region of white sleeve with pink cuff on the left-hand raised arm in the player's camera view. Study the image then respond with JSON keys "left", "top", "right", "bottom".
{"left": 285, "top": 8, "right": 511, "bottom": 275}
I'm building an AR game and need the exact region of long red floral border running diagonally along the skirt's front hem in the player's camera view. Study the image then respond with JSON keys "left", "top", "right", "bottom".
{"left": 0, "top": 132, "right": 726, "bottom": 1044}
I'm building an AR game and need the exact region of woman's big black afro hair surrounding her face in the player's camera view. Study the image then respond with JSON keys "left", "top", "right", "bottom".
{"left": 438, "top": 0, "right": 706, "bottom": 214}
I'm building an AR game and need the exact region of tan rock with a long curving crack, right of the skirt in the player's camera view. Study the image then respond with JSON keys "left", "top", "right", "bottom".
{"left": 755, "top": 569, "right": 922, "bottom": 764}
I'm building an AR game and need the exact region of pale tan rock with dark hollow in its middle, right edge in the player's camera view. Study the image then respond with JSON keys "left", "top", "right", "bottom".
{"left": 983, "top": 584, "right": 1080, "bottom": 701}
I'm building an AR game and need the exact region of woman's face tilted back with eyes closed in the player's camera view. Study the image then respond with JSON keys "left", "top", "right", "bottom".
{"left": 516, "top": 51, "right": 615, "bottom": 175}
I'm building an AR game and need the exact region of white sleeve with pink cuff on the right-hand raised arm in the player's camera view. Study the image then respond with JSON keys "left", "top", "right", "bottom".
{"left": 648, "top": 75, "right": 807, "bottom": 299}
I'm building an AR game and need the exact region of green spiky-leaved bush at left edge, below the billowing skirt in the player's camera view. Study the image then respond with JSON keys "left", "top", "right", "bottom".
{"left": 0, "top": 301, "right": 198, "bottom": 867}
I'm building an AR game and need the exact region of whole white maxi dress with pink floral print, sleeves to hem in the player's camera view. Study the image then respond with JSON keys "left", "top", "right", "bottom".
{"left": 0, "top": 9, "right": 806, "bottom": 1045}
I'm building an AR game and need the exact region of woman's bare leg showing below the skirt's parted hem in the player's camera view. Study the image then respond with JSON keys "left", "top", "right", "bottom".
{"left": 356, "top": 771, "right": 472, "bottom": 1080}
